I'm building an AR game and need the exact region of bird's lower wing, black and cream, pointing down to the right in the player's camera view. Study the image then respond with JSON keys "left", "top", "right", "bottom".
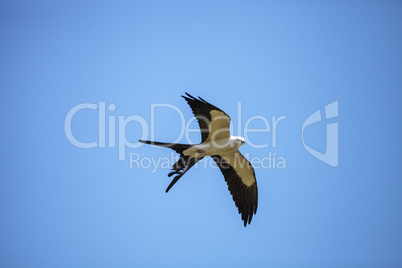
{"left": 212, "top": 150, "right": 258, "bottom": 226}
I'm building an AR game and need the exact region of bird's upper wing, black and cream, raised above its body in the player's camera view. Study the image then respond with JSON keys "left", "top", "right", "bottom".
{"left": 182, "top": 92, "right": 230, "bottom": 142}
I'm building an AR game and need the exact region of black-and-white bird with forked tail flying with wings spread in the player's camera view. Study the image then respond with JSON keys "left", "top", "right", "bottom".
{"left": 139, "top": 93, "right": 258, "bottom": 226}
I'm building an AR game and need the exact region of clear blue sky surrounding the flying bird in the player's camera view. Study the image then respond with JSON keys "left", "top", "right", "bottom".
{"left": 0, "top": 1, "right": 402, "bottom": 267}
